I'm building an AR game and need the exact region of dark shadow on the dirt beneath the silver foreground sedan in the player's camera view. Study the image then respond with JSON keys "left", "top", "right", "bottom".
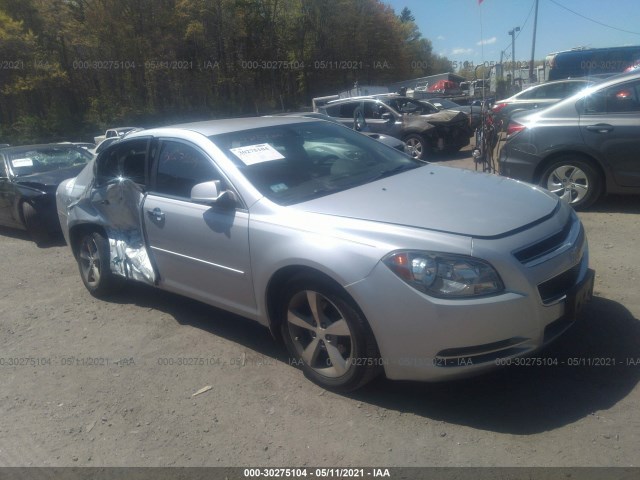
{"left": 107, "top": 285, "right": 640, "bottom": 434}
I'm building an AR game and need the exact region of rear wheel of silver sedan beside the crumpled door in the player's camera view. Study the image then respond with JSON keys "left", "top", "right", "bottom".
{"left": 76, "top": 232, "right": 124, "bottom": 298}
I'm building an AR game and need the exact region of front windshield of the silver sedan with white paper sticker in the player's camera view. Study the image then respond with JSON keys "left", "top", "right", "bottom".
{"left": 209, "top": 122, "right": 424, "bottom": 205}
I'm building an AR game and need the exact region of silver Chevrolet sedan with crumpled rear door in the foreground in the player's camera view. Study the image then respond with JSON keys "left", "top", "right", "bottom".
{"left": 57, "top": 117, "right": 593, "bottom": 391}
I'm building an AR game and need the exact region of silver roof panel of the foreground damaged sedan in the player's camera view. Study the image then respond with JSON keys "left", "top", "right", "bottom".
{"left": 126, "top": 116, "right": 320, "bottom": 139}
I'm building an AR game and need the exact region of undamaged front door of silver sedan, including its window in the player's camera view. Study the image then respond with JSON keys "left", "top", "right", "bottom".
{"left": 143, "top": 139, "right": 255, "bottom": 313}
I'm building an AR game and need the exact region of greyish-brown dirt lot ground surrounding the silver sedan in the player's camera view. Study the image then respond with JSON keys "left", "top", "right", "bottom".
{"left": 0, "top": 151, "right": 640, "bottom": 467}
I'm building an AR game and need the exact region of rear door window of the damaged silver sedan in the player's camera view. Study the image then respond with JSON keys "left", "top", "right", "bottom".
{"left": 97, "top": 138, "right": 149, "bottom": 185}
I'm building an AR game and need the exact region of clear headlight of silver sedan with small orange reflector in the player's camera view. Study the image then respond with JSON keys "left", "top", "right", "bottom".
{"left": 382, "top": 251, "right": 504, "bottom": 298}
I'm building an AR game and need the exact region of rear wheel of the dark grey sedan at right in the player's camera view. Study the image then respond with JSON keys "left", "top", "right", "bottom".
{"left": 539, "top": 155, "right": 602, "bottom": 210}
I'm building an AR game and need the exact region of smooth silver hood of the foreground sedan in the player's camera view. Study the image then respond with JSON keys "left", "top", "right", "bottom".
{"left": 295, "top": 165, "right": 559, "bottom": 238}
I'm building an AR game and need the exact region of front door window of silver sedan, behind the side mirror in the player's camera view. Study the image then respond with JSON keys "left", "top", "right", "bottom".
{"left": 154, "top": 141, "right": 225, "bottom": 199}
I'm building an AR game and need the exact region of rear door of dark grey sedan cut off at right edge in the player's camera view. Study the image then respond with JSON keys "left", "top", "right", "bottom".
{"left": 580, "top": 80, "right": 640, "bottom": 187}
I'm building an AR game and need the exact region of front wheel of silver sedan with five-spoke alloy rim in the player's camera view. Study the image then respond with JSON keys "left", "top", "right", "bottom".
{"left": 278, "top": 276, "right": 381, "bottom": 392}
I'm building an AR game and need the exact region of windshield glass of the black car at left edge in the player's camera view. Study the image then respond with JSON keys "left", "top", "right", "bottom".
{"left": 8, "top": 146, "right": 93, "bottom": 177}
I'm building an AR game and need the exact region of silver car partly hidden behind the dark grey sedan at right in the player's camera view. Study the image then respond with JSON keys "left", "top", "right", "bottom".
{"left": 491, "top": 78, "right": 594, "bottom": 131}
